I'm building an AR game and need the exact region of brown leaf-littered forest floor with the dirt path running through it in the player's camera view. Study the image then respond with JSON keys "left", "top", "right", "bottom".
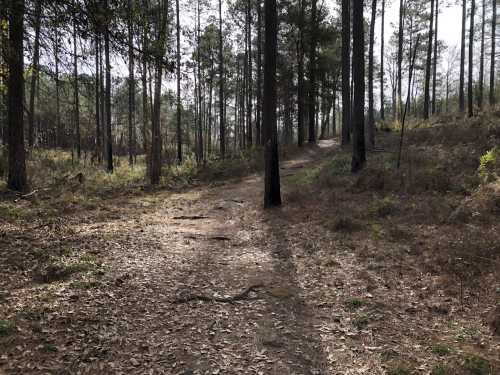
{"left": 0, "top": 116, "right": 500, "bottom": 375}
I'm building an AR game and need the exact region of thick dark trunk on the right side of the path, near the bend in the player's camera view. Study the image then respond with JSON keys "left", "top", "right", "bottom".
{"left": 351, "top": 0, "right": 366, "bottom": 173}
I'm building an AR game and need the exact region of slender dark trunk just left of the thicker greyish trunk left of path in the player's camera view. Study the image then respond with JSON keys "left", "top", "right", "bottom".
{"left": 128, "top": 0, "right": 136, "bottom": 165}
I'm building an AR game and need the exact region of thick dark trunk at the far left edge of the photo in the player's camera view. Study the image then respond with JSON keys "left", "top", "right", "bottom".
{"left": 7, "top": 0, "right": 28, "bottom": 191}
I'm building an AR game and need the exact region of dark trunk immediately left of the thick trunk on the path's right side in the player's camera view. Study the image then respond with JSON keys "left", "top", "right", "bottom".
{"left": 340, "top": 0, "right": 351, "bottom": 146}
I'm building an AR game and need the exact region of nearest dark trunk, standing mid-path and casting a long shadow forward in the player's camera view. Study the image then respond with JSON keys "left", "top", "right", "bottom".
{"left": 263, "top": 0, "right": 281, "bottom": 208}
